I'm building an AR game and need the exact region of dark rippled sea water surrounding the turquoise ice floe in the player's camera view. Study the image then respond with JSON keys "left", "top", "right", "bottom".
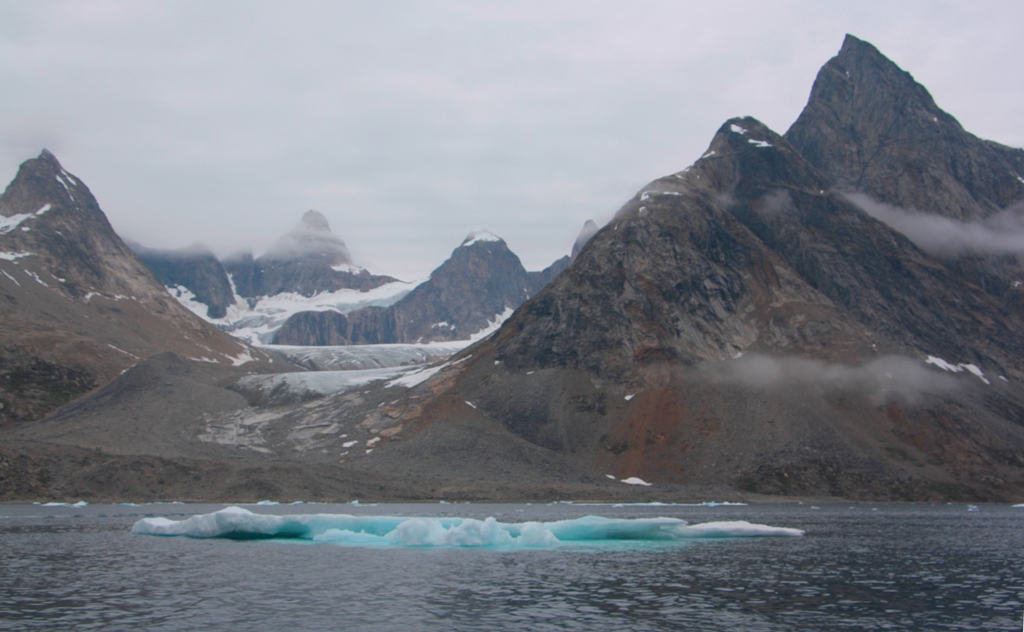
{"left": 0, "top": 504, "right": 1024, "bottom": 631}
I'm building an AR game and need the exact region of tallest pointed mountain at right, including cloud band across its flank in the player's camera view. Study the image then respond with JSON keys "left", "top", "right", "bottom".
{"left": 785, "top": 36, "right": 1024, "bottom": 307}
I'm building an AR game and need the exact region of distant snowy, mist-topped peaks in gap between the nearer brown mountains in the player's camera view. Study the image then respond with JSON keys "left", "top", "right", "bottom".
{"left": 133, "top": 211, "right": 596, "bottom": 345}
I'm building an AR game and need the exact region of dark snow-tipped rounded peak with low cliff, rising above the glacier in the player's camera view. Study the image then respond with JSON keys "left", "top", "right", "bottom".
{"left": 274, "top": 234, "right": 536, "bottom": 345}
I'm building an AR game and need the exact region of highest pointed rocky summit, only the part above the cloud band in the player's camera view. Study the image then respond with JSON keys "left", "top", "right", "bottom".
{"left": 785, "top": 35, "right": 1024, "bottom": 219}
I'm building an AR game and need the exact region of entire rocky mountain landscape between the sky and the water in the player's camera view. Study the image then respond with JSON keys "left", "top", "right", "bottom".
{"left": 0, "top": 36, "right": 1024, "bottom": 502}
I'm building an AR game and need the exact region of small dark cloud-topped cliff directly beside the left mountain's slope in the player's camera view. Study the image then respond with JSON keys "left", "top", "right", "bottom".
{"left": 132, "top": 244, "right": 234, "bottom": 319}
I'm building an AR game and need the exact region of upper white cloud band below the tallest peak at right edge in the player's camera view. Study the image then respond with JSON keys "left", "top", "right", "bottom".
{"left": 846, "top": 194, "right": 1024, "bottom": 258}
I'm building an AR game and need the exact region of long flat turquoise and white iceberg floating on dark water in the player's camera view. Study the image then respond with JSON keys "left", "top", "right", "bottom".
{"left": 131, "top": 507, "right": 804, "bottom": 548}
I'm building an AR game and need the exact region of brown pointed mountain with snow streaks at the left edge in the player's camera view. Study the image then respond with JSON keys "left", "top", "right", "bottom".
{"left": 0, "top": 150, "right": 272, "bottom": 424}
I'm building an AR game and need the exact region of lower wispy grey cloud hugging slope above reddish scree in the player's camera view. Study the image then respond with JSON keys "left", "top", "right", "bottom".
{"left": 700, "top": 354, "right": 963, "bottom": 404}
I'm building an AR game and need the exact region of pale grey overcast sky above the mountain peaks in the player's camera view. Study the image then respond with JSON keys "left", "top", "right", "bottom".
{"left": 0, "top": 0, "right": 1024, "bottom": 279}
